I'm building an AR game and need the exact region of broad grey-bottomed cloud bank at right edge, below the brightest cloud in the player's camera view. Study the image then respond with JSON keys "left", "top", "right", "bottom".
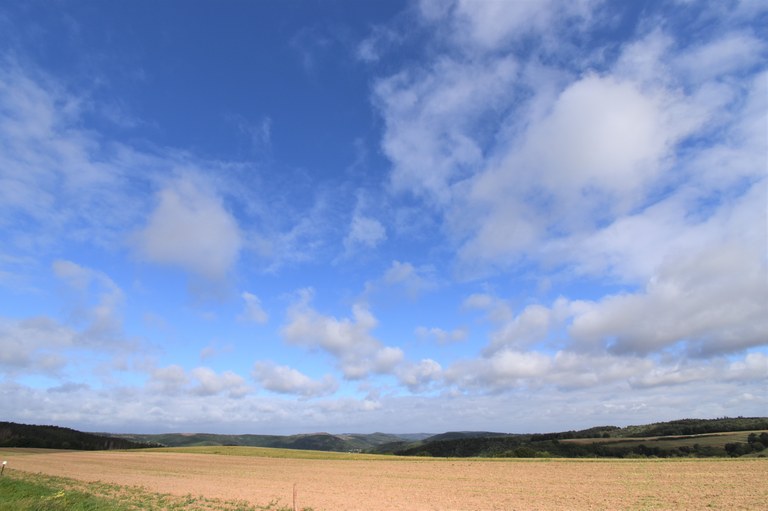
{"left": 465, "top": 182, "right": 768, "bottom": 357}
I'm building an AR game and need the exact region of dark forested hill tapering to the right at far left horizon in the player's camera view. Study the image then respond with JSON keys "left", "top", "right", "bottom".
{"left": 0, "top": 422, "right": 156, "bottom": 451}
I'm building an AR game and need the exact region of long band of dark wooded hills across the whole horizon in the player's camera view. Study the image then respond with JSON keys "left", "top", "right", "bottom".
{"left": 7, "top": 417, "right": 768, "bottom": 458}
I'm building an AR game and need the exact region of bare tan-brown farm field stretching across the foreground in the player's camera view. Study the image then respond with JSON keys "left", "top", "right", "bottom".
{"left": 2, "top": 449, "right": 768, "bottom": 511}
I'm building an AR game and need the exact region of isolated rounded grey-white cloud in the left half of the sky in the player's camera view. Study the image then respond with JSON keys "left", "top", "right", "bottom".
{"left": 135, "top": 176, "right": 242, "bottom": 280}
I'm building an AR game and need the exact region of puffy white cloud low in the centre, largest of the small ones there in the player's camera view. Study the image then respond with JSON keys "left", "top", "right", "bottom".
{"left": 282, "top": 290, "right": 403, "bottom": 380}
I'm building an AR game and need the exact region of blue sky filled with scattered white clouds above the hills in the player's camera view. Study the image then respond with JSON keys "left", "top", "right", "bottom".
{"left": 0, "top": 0, "right": 768, "bottom": 434}
